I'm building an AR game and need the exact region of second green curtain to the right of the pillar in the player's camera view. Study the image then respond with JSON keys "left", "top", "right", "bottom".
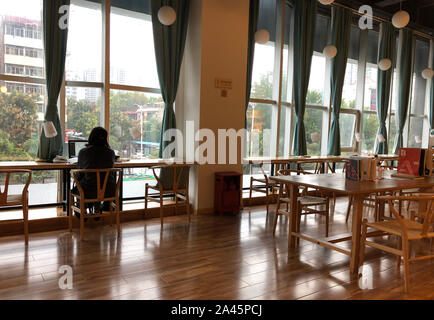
{"left": 293, "top": 0, "right": 318, "bottom": 155}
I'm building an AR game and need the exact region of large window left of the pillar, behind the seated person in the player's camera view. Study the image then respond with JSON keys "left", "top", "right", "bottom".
{"left": 0, "top": 0, "right": 164, "bottom": 210}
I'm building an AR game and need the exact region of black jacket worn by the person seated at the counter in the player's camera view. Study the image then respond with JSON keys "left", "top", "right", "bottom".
{"left": 77, "top": 145, "right": 116, "bottom": 199}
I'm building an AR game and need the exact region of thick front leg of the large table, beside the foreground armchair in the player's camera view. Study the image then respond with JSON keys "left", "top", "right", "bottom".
{"left": 350, "top": 195, "right": 364, "bottom": 274}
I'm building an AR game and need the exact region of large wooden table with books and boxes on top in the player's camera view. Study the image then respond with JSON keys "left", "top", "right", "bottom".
{"left": 270, "top": 173, "right": 434, "bottom": 274}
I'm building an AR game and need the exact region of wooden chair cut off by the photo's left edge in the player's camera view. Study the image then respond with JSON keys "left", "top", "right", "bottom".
{"left": 0, "top": 170, "right": 32, "bottom": 245}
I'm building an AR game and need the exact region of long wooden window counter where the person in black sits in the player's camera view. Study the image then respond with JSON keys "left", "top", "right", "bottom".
{"left": 0, "top": 159, "right": 192, "bottom": 211}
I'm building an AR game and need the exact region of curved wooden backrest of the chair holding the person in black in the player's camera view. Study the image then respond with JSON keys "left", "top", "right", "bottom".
{"left": 71, "top": 168, "right": 122, "bottom": 202}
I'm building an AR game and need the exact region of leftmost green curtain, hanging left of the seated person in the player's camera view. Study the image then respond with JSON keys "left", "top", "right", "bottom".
{"left": 38, "top": 0, "right": 70, "bottom": 160}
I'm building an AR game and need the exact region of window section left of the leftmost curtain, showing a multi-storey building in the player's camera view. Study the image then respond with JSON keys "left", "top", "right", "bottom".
{"left": 0, "top": 0, "right": 45, "bottom": 160}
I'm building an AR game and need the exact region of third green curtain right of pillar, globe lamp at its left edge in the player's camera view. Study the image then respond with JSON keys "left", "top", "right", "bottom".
{"left": 327, "top": 7, "right": 351, "bottom": 156}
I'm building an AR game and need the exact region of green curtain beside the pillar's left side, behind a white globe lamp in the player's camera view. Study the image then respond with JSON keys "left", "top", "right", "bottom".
{"left": 151, "top": 0, "right": 190, "bottom": 158}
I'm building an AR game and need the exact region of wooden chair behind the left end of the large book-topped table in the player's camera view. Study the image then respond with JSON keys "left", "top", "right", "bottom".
{"left": 273, "top": 169, "right": 330, "bottom": 237}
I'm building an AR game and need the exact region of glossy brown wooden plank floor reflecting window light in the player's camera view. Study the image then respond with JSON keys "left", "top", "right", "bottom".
{"left": 0, "top": 198, "right": 434, "bottom": 300}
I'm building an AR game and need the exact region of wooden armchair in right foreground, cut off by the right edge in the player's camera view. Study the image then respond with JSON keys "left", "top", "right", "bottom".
{"left": 360, "top": 195, "right": 434, "bottom": 292}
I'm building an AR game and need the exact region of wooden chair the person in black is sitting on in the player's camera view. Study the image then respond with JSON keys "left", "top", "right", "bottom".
{"left": 68, "top": 169, "right": 122, "bottom": 241}
